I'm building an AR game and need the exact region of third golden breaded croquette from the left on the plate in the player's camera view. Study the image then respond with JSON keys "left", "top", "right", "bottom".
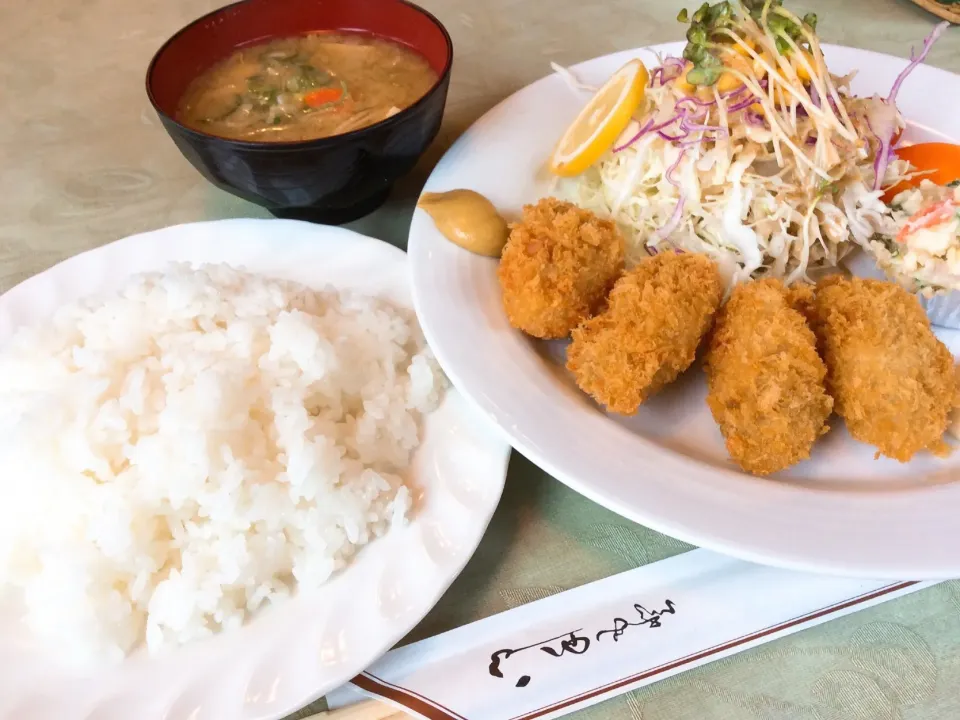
{"left": 705, "top": 279, "right": 833, "bottom": 475}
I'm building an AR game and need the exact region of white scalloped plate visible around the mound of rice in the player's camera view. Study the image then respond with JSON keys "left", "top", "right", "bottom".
{"left": 0, "top": 220, "right": 509, "bottom": 720}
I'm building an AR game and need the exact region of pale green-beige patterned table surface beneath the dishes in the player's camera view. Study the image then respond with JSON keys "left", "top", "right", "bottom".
{"left": 0, "top": 0, "right": 960, "bottom": 720}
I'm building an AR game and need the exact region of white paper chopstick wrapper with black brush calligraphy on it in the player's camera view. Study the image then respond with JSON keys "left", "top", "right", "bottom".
{"left": 327, "top": 550, "right": 935, "bottom": 720}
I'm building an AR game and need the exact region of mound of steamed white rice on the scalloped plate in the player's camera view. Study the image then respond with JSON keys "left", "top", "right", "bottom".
{"left": 0, "top": 266, "right": 444, "bottom": 660}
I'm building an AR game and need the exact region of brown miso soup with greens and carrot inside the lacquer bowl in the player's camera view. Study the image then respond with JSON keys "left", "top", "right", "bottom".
{"left": 177, "top": 32, "right": 437, "bottom": 142}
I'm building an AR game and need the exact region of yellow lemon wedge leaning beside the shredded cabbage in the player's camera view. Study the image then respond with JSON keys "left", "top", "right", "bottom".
{"left": 550, "top": 60, "right": 650, "bottom": 177}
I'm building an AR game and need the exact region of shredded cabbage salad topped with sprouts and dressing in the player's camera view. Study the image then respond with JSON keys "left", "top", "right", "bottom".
{"left": 555, "top": 0, "right": 946, "bottom": 284}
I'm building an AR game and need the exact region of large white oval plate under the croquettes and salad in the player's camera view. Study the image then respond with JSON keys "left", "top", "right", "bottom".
{"left": 408, "top": 38, "right": 960, "bottom": 578}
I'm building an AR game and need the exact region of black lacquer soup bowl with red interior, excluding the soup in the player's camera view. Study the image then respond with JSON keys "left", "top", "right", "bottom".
{"left": 147, "top": 0, "right": 453, "bottom": 224}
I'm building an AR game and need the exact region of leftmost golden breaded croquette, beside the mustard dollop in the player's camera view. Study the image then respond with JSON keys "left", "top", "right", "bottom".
{"left": 497, "top": 198, "right": 624, "bottom": 339}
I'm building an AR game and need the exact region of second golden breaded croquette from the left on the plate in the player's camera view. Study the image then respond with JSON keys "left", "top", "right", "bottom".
{"left": 567, "top": 252, "right": 723, "bottom": 415}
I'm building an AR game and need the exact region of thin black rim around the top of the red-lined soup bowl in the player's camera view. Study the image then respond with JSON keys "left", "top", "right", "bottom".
{"left": 145, "top": 0, "right": 453, "bottom": 150}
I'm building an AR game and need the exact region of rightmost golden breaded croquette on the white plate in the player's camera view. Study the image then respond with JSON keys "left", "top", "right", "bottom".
{"left": 814, "top": 276, "right": 956, "bottom": 462}
